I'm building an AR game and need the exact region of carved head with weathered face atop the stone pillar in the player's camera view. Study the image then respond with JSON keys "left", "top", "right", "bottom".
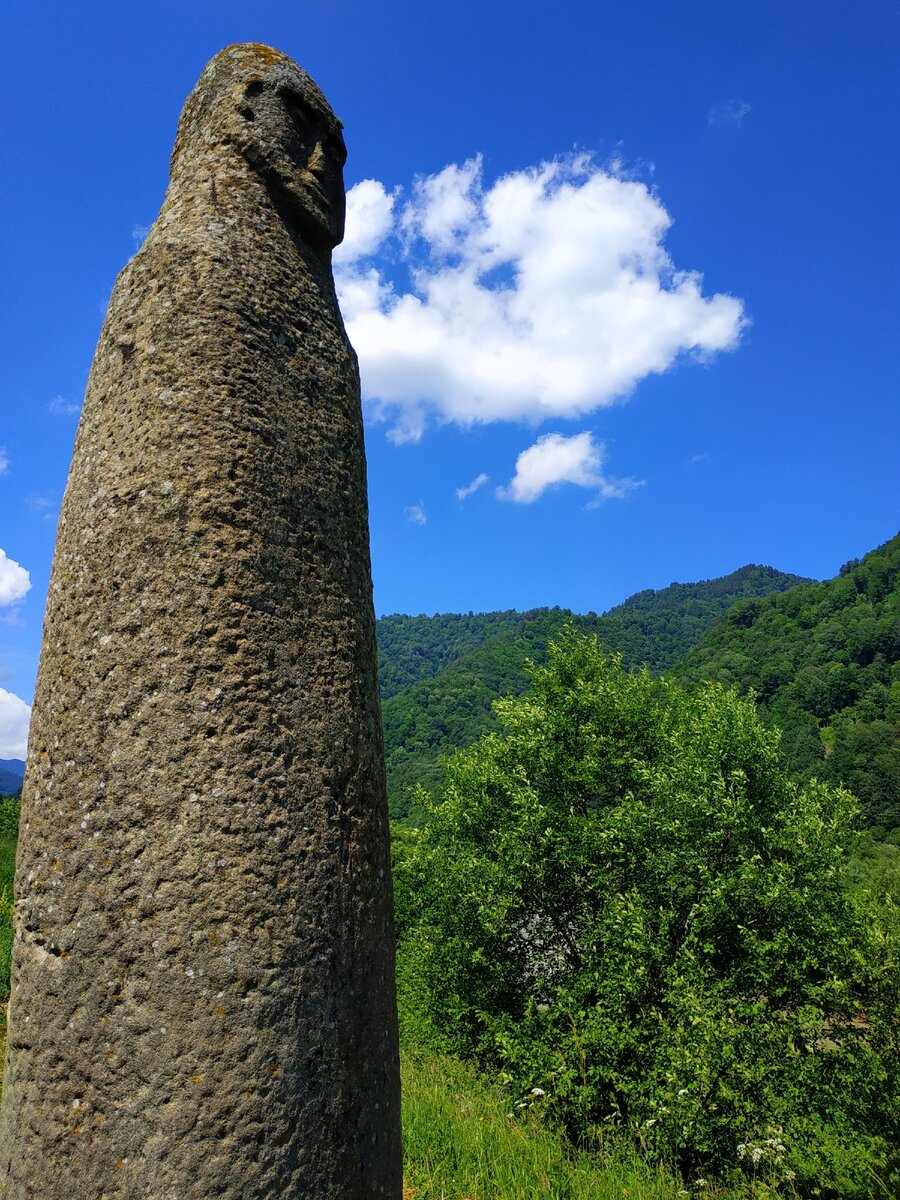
{"left": 172, "top": 43, "right": 347, "bottom": 253}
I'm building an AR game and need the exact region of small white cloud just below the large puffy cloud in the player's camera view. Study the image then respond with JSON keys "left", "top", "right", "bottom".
{"left": 497, "top": 430, "right": 641, "bottom": 504}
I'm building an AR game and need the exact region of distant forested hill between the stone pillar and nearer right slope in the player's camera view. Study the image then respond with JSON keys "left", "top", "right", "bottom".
{"left": 377, "top": 565, "right": 809, "bottom": 820}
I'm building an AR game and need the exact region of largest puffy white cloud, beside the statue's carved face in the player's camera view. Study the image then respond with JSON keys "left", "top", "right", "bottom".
{"left": 336, "top": 155, "right": 744, "bottom": 442}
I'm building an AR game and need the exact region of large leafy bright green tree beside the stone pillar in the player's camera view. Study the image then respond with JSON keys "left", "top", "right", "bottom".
{"left": 397, "top": 635, "right": 900, "bottom": 1196}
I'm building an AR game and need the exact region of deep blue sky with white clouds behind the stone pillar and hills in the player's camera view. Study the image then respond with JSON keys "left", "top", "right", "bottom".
{"left": 0, "top": 0, "right": 900, "bottom": 757}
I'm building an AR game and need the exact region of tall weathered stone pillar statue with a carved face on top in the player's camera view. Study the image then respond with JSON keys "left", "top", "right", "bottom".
{"left": 0, "top": 44, "right": 401, "bottom": 1200}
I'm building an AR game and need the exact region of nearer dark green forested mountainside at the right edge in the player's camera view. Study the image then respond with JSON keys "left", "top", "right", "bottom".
{"left": 674, "top": 534, "right": 900, "bottom": 829}
